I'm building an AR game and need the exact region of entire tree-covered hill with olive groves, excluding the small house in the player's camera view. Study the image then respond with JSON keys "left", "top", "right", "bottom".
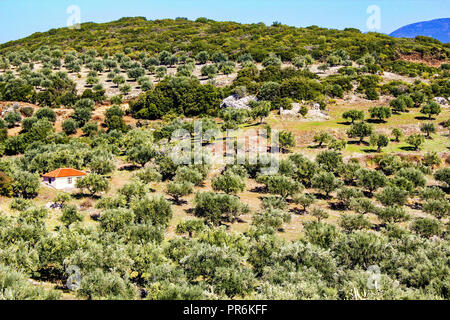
{"left": 0, "top": 18, "right": 450, "bottom": 300}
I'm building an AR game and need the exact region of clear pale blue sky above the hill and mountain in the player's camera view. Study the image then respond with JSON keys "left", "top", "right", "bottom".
{"left": 0, "top": 0, "right": 450, "bottom": 43}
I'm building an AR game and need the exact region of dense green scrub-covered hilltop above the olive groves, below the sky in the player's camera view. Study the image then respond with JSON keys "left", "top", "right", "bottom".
{"left": 0, "top": 17, "right": 450, "bottom": 62}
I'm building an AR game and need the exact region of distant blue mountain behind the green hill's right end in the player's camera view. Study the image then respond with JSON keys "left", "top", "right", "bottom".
{"left": 390, "top": 18, "right": 450, "bottom": 43}
